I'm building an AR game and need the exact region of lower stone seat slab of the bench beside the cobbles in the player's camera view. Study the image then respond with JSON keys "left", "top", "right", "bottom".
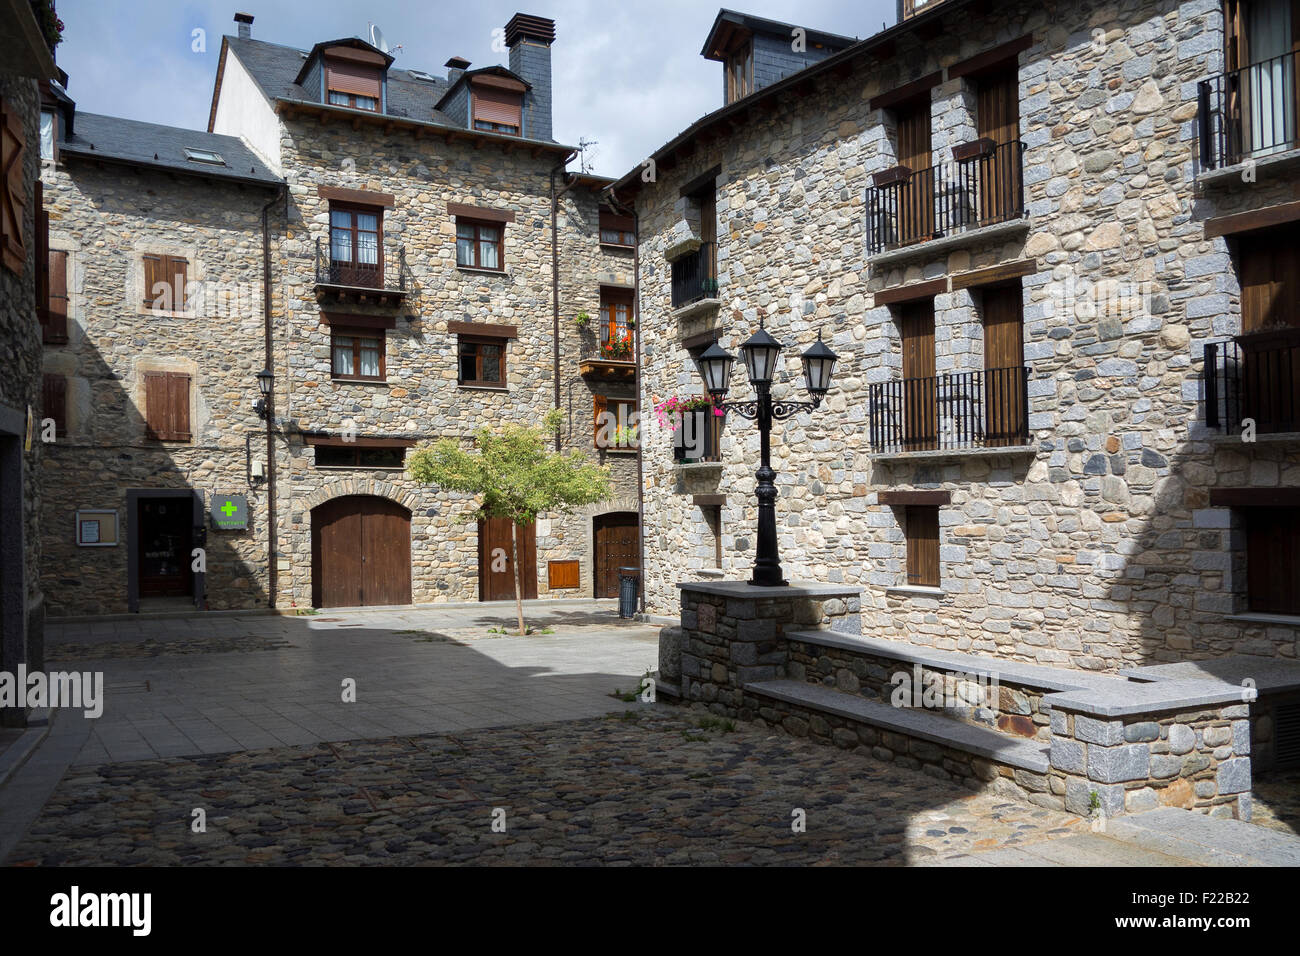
{"left": 745, "top": 680, "right": 1048, "bottom": 774}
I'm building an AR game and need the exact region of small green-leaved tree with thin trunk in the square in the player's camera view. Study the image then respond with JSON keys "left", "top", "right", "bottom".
{"left": 407, "top": 408, "right": 611, "bottom": 635}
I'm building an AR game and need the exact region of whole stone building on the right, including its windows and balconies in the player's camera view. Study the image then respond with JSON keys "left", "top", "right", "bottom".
{"left": 611, "top": 0, "right": 1300, "bottom": 812}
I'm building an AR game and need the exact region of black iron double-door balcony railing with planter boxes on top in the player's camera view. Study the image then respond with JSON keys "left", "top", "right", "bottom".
{"left": 867, "top": 139, "right": 1026, "bottom": 255}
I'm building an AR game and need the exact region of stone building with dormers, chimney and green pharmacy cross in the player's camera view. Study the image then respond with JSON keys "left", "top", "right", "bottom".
{"left": 30, "top": 14, "right": 640, "bottom": 614}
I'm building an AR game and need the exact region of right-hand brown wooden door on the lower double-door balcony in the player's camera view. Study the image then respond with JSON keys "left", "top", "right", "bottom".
{"left": 983, "top": 285, "right": 1028, "bottom": 445}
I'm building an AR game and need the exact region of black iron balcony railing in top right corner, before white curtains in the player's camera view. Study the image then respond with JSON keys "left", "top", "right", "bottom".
{"left": 1196, "top": 51, "right": 1300, "bottom": 169}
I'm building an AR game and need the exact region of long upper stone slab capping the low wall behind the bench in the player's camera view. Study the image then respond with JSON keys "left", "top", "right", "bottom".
{"left": 785, "top": 630, "right": 1131, "bottom": 691}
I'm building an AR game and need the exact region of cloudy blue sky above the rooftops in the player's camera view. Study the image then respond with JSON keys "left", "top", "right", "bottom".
{"left": 59, "top": 0, "right": 896, "bottom": 176}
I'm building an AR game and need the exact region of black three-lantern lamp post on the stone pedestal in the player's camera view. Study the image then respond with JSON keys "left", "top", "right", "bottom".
{"left": 699, "top": 321, "right": 840, "bottom": 588}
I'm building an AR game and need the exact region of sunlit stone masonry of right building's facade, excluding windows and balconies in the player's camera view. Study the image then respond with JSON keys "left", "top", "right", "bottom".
{"left": 636, "top": 0, "right": 1300, "bottom": 671}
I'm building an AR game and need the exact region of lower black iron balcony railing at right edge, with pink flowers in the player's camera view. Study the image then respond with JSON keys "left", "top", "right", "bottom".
{"left": 1205, "top": 332, "right": 1300, "bottom": 434}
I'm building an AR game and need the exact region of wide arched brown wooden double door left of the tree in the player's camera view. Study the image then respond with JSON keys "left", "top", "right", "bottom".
{"left": 312, "top": 496, "right": 411, "bottom": 607}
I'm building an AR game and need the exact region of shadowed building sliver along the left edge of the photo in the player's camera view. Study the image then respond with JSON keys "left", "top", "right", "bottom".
{"left": 0, "top": 0, "right": 57, "bottom": 727}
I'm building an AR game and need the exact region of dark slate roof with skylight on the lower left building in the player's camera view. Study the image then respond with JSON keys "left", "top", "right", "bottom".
{"left": 59, "top": 111, "right": 282, "bottom": 185}
